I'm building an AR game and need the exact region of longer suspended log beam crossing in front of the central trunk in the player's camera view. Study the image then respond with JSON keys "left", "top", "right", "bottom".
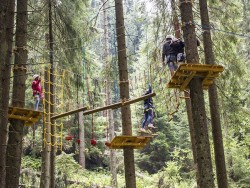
{"left": 83, "top": 93, "right": 156, "bottom": 115}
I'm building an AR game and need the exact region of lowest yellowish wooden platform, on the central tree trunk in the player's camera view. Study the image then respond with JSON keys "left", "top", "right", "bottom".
{"left": 105, "top": 135, "right": 153, "bottom": 149}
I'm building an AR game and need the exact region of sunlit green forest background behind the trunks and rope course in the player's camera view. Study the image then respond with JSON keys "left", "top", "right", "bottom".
{"left": 0, "top": 0, "right": 250, "bottom": 188}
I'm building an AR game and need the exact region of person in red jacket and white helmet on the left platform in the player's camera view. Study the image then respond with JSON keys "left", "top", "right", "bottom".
{"left": 32, "top": 74, "right": 43, "bottom": 111}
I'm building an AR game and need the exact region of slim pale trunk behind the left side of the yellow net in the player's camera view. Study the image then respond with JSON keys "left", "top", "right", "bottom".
{"left": 40, "top": 67, "right": 51, "bottom": 188}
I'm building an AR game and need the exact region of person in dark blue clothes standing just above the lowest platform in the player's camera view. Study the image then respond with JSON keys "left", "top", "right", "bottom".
{"left": 140, "top": 85, "right": 155, "bottom": 132}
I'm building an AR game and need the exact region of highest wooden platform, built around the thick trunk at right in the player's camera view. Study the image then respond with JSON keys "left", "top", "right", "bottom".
{"left": 167, "top": 64, "right": 224, "bottom": 91}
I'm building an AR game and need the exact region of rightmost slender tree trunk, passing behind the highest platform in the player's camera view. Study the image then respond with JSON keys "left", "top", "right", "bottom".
{"left": 199, "top": 0, "right": 228, "bottom": 188}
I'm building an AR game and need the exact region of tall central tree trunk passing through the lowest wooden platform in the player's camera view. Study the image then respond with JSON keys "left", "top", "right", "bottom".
{"left": 115, "top": 0, "right": 136, "bottom": 188}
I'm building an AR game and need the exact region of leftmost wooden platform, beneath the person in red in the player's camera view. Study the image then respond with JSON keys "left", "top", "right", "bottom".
{"left": 8, "top": 107, "right": 43, "bottom": 126}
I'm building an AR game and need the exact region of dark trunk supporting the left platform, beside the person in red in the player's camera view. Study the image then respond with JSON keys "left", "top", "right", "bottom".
{"left": 6, "top": 0, "right": 28, "bottom": 187}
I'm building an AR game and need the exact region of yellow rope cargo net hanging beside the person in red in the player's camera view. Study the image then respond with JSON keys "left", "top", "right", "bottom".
{"left": 43, "top": 67, "right": 66, "bottom": 151}
